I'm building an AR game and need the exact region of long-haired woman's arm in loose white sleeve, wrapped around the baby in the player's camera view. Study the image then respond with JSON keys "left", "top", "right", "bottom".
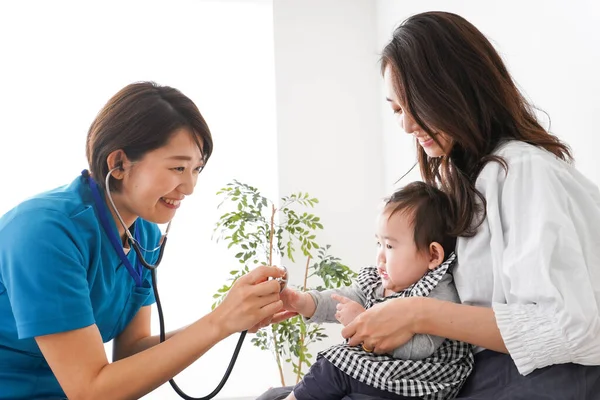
{"left": 343, "top": 155, "right": 600, "bottom": 375}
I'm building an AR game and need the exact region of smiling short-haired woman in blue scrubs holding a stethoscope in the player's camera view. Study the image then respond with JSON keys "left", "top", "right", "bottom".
{"left": 0, "top": 82, "right": 282, "bottom": 400}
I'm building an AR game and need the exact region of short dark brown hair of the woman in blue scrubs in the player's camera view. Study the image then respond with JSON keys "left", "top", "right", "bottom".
{"left": 86, "top": 82, "right": 213, "bottom": 190}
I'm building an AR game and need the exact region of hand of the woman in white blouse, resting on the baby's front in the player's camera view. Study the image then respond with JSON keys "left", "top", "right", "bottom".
{"left": 342, "top": 297, "right": 419, "bottom": 354}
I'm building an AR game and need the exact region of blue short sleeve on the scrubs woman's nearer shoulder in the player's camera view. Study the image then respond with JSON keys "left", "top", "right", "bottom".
{"left": 0, "top": 210, "right": 95, "bottom": 339}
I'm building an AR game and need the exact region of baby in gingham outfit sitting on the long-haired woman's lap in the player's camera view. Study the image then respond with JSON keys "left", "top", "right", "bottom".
{"left": 281, "top": 182, "right": 473, "bottom": 400}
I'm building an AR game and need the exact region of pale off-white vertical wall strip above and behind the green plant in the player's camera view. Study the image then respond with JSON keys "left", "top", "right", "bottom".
{"left": 271, "top": 0, "right": 384, "bottom": 385}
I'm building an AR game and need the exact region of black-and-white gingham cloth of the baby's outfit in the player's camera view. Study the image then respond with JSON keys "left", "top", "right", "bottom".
{"left": 319, "top": 253, "right": 474, "bottom": 400}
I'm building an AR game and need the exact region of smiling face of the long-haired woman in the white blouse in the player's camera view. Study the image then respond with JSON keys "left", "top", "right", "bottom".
{"left": 383, "top": 65, "right": 452, "bottom": 157}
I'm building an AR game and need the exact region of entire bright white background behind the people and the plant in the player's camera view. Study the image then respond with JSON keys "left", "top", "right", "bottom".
{"left": 0, "top": 0, "right": 600, "bottom": 399}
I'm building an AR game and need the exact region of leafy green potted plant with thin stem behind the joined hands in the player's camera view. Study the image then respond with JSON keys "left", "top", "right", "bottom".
{"left": 212, "top": 180, "right": 356, "bottom": 386}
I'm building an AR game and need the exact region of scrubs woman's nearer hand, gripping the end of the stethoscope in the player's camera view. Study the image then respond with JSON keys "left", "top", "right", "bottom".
{"left": 213, "top": 266, "right": 283, "bottom": 335}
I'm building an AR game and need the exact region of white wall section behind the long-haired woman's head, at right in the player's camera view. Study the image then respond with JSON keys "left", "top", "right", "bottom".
{"left": 377, "top": 0, "right": 600, "bottom": 191}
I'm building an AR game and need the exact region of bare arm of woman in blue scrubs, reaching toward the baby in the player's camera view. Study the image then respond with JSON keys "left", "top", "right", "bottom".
{"left": 36, "top": 267, "right": 281, "bottom": 400}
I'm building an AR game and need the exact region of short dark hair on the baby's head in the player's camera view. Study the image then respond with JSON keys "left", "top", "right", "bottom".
{"left": 385, "top": 182, "right": 456, "bottom": 259}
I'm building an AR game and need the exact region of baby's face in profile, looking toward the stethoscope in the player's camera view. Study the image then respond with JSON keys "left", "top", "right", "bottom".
{"left": 375, "top": 210, "right": 429, "bottom": 292}
